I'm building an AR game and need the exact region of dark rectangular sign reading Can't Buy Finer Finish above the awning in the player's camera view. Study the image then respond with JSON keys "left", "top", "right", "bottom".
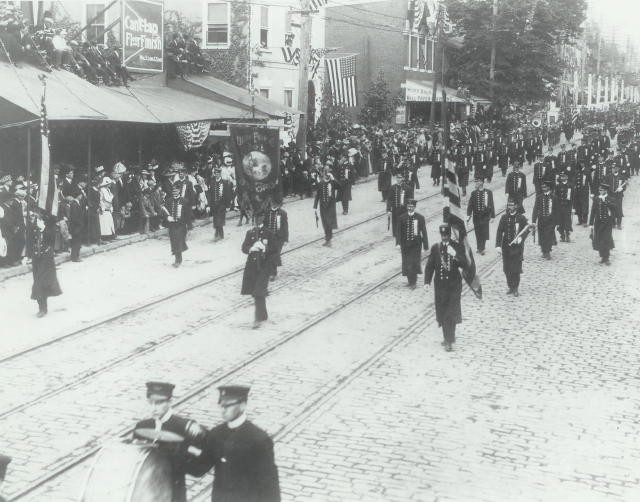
{"left": 122, "top": 0, "right": 164, "bottom": 72}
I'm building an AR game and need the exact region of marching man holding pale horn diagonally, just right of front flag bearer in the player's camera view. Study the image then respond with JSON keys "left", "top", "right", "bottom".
{"left": 496, "top": 199, "right": 529, "bottom": 296}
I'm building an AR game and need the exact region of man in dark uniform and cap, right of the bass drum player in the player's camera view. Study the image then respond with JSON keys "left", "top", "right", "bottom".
{"left": 192, "top": 385, "right": 280, "bottom": 502}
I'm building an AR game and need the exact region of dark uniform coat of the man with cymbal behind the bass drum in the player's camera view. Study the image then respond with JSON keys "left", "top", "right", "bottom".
{"left": 133, "top": 414, "right": 202, "bottom": 502}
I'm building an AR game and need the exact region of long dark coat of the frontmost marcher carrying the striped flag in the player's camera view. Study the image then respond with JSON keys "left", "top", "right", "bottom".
{"left": 424, "top": 241, "right": 465, "bottom": 326}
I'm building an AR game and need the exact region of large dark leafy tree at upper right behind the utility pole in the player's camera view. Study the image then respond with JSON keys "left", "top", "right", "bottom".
{"left": 447, "top": 0, "right": 586, "bottom": 106}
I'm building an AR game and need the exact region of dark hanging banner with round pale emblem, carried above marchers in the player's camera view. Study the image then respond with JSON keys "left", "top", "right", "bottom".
{"left": 229, "top": 125, "right": 282, "bottom": 211}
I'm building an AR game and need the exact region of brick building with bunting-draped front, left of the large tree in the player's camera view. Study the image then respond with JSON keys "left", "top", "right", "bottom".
{"left": 325, "top": 0, "right": 469, "bottom": 124}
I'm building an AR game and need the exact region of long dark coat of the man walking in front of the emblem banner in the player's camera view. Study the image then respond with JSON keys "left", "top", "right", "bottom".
{"left": 240, "top": 227, "right": 276, "bottom": 297}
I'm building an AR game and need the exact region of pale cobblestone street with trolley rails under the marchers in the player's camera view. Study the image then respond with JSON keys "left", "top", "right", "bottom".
{"left": 0, "top": 158, "right": 640, "bottom": 502}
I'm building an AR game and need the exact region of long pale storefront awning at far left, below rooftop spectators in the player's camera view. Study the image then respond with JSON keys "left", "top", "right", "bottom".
{"left": 0, "top": 62, "right": 269, "bottom": 126}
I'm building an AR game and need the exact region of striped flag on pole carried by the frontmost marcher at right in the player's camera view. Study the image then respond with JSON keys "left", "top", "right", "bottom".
{"left": 442, "top": 89, "right": 482, "bottom": 299}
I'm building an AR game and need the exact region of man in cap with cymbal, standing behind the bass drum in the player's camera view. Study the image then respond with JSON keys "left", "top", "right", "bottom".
{"left": 133, "top": 382, "right": 205, "bottom": 502}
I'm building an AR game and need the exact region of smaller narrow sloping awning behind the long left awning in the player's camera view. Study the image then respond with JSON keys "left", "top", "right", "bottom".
{"left": 169, "top": 75, "right": 302, "bottom": 118}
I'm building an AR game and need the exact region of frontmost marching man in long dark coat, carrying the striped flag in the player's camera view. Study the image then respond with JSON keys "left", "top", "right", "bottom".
{"left": 424, "top": 224, "right": 465, "bottom": 352}
